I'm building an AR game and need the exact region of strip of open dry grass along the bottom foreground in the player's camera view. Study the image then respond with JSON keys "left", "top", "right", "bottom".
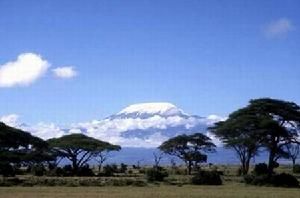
{"left": 0, "top": 184, "right": 300, "bottom": 198}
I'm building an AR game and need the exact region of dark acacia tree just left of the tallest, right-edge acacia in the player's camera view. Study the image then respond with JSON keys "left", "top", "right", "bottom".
{"left": 209, "top": 112, "right": 262, "bottom": 175}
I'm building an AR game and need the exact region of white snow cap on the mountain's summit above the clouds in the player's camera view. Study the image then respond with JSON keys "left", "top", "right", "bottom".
{"left": 118, "top": 102, "right": 184, "bottom": 116}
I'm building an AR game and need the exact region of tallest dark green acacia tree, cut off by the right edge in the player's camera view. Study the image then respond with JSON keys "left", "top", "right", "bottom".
{"left": 247, "top": 98, "right": 300, "bottom": 174}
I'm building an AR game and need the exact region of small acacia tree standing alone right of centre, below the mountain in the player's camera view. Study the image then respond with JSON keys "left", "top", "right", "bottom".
{"left": 159, "top": 133, "right": 216, "bottom": 175}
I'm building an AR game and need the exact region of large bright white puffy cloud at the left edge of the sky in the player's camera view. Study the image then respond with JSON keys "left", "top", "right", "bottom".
{"left": 0, "top": 53, "right": 50, "bottom": 87}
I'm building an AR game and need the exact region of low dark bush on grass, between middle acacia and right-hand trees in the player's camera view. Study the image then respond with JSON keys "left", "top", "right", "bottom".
{"left": 191, "top": 171, "right": 222, "bottom": 185}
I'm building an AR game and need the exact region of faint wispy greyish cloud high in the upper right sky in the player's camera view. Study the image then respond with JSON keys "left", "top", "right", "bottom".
{"left": 264, "top": 18, "right": 294, "bottom": 38}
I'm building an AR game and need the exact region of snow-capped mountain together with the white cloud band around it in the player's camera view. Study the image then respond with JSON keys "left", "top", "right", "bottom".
{"left": 2, "top": 102, "right": 223, "bottom": 148}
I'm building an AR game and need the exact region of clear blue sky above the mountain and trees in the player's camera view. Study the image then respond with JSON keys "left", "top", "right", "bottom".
{"left": 0, "top": 0, "right": 300, "bottom": 124}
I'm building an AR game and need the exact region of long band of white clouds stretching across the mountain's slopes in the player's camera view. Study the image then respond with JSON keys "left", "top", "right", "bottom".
{"left": 0, "top": 111, "right": 226, "bottom": 148}
